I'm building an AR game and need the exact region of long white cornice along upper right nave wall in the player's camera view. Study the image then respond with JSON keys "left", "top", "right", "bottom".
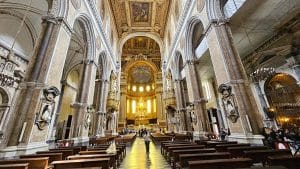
{"left": 165, "top": 0, "right": 195, "bottom": 69}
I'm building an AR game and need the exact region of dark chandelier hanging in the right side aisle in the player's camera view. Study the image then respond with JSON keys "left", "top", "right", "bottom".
{"left": 250, "top": 67, "right": 276, "bottom": 82}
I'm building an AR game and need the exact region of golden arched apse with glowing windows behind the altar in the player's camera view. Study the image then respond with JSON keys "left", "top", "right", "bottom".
{"left": 119, "top": 36, "right": 166, "bottom": 132}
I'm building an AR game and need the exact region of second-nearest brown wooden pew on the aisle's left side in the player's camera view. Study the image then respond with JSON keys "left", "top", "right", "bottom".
{"left": 68, "top": 154, "right": 118, "bottom": 168}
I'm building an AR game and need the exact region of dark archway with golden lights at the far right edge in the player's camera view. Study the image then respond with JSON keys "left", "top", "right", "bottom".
{"left": 265, "top": 73, "right": 300, "bottom": 128}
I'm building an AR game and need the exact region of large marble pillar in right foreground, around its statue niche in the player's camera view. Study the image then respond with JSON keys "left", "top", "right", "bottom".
{"left": 206, "top": 20, "right": 263, "bottom": 142}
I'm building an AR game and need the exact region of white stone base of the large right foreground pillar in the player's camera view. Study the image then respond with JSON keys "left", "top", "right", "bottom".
{"left": 228, "top": 133, "right": 264, "bottom": 145}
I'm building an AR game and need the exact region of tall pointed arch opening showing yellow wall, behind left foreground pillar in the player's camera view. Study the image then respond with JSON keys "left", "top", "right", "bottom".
{"left": 55, "top": 18, "right": 89, "bottom": 139}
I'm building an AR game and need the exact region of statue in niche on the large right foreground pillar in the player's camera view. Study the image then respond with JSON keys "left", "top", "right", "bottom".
{"left": 218, "top": 84, "right": 240, "bottom": 123}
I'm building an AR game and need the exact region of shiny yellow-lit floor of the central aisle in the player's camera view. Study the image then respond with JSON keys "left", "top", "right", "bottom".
{"left": 120, "top": 137, "right": 171, "bottom": 169}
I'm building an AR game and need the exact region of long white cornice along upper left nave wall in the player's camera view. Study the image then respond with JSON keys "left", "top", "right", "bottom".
{"left": 85, "top": 0, "right": 117, "bottom": 70}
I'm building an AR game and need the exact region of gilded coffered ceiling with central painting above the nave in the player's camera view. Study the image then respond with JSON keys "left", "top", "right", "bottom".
{"left": 110, "top": 0, "right": 170, "bottom": 37}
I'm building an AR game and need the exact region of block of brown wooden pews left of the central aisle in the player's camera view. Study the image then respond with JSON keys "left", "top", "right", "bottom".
{"left": 0, "top": 141, "right": 126, "bottom": 169}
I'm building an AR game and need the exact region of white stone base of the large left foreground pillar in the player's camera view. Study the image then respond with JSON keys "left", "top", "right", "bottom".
{"left": 0, "top": 142, "right": 49, "bottom": 158}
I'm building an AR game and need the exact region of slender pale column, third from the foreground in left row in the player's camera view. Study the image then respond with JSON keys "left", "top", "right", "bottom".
{"left": 97, "top": 79, "right": 109, "bottom": 136}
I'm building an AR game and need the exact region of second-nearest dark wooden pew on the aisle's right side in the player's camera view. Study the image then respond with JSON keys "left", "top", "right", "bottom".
{"left": 178, "top": 152, "right": 231, "bottom": 167}
